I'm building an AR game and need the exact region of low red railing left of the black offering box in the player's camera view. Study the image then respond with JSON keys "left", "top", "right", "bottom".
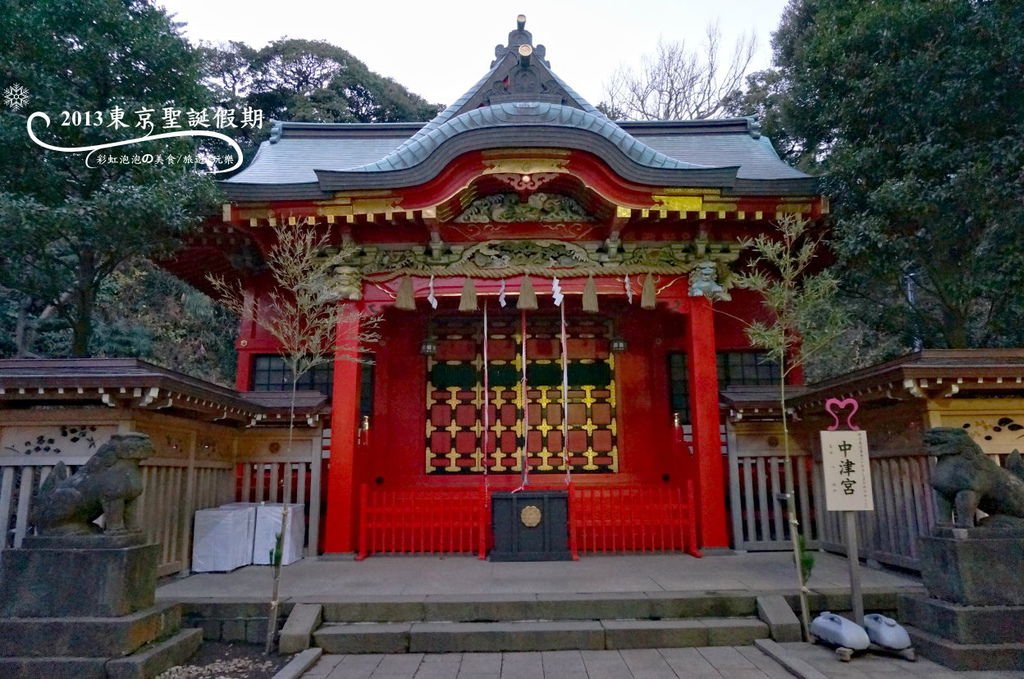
{"left": 356, "top": 483, "right": 490, "bottom": 559}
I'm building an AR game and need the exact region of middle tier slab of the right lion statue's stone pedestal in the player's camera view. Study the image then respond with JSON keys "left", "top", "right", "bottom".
{"left": 899, "top": 593, "right": 1024, "bottom": 644}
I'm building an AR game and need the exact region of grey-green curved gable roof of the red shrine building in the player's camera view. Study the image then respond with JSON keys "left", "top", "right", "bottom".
{"left": 221, "top": 16, "right": 817, "bottom": 201}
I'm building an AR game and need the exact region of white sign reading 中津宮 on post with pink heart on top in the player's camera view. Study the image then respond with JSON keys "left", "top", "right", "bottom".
{"left": 820, "top": 398, "right": 874, "bottom": 626}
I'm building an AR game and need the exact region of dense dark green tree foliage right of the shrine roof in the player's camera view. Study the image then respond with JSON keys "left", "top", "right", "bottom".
{"left": 748, "top": 0, "right": 1024, "bottom": 347}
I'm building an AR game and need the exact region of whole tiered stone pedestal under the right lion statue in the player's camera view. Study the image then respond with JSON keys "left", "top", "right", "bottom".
{"left": 899, "top": 527, "right": 1024, "bottom": 670}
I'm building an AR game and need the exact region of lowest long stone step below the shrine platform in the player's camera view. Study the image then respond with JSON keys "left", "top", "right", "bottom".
{"left": 313, "top": 618, "right": 768, "bottom": 653}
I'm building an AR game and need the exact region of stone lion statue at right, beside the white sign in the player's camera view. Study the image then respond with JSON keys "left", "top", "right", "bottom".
{"left": 925, "top": 427, "right": 1024, "bottom": 528}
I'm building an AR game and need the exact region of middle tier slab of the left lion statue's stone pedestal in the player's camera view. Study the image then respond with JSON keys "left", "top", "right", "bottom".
{"left": 0, "top": 604, "right": 181, "bottom": 657}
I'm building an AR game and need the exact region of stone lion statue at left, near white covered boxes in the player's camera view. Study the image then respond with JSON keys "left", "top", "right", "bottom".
{"left": 31, "top": 433, "right": 154, "bottom": 536}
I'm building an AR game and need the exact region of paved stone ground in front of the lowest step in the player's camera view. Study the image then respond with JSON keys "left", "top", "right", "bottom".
{"left": 303, "top": 643, "right": 1024, "bottom": 679}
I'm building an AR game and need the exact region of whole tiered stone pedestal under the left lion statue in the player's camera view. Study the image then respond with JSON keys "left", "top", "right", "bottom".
{"left": 0, "top": 533, "right": 202, "bottom": 679}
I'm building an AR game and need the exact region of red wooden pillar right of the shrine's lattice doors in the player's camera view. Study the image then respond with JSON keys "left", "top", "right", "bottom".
{"left": 686, "top": 297, "right": 729, "bottom": 548}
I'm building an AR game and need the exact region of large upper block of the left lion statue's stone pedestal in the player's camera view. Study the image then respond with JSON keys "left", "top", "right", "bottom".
{"left": 0, "top": 544, "right": 160, "bottom": 618}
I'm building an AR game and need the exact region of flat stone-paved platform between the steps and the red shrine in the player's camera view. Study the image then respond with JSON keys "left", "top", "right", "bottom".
{"left": 157, "top": 552, "right": 921, "bottom": 603}
